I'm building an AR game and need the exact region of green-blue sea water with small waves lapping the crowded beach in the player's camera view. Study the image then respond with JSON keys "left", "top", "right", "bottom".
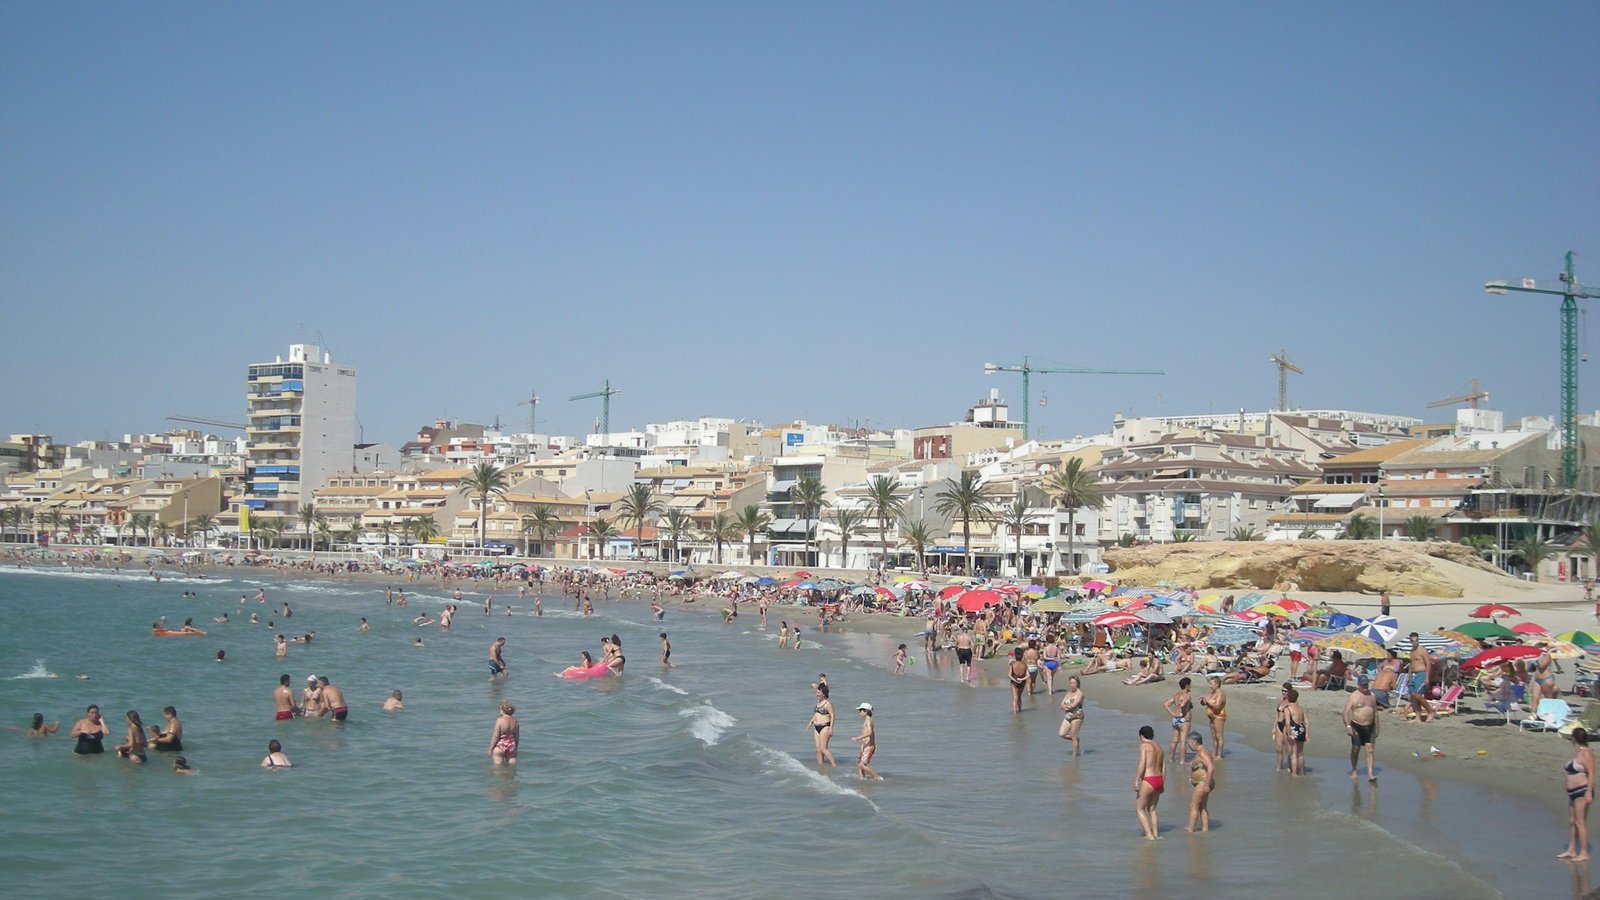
{"left": 0, "top": 569, "right": 1586, "bottom": 897}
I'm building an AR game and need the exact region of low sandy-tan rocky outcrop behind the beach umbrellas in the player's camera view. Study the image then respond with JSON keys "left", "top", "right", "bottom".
{"left": 1104, "top": 541, "right": 1515, "bottom": 597}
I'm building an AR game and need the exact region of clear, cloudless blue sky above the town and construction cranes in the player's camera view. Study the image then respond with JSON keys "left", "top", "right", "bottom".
{"left": 0, "top": 2, "right": 1600, "bottom": 440}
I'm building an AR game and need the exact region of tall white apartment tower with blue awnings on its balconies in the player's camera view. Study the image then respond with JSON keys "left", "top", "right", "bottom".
{"left": 245, "top": 344, "right": 355, "bottom": 517}
